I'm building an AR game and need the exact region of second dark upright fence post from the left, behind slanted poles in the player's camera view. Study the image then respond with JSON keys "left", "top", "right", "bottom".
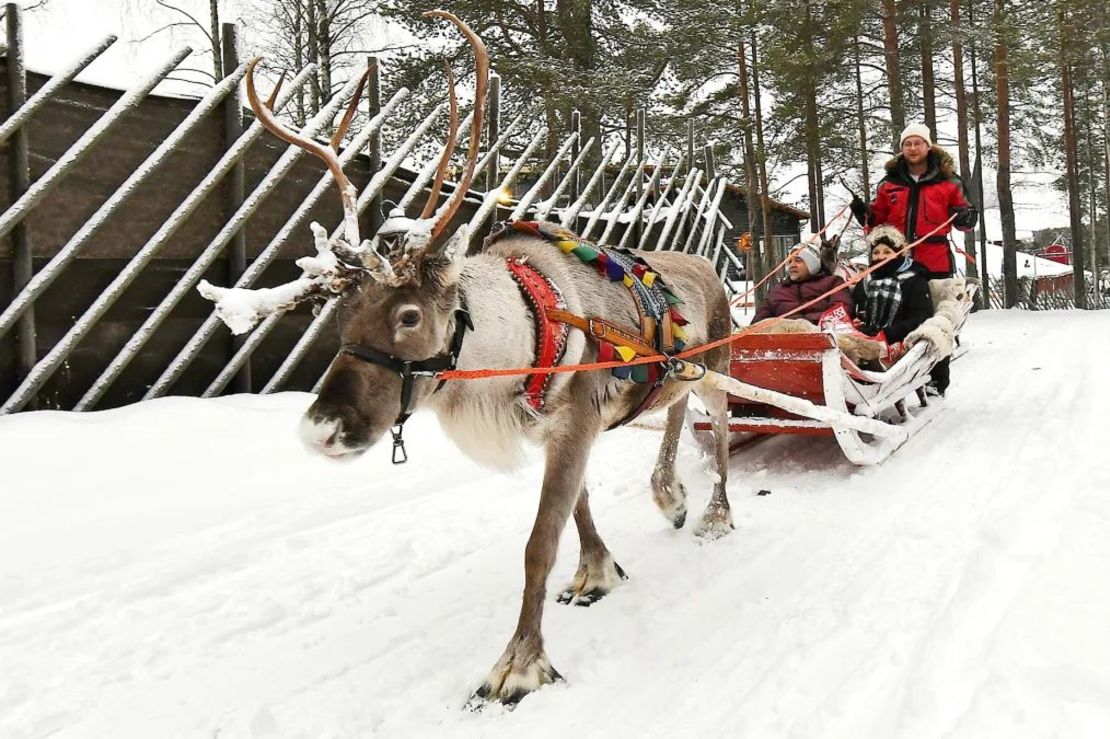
{"left": 220, "top": 23, "right": 251, "bottom": 393}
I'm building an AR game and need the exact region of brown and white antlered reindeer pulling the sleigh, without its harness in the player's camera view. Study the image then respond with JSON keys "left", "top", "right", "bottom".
{"left": 201, "top": 11, "right": 734, "bottom": 706}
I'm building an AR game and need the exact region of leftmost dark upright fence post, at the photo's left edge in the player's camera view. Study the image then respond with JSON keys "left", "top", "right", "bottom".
{"left": 6, "top": 2, "right": 38, "bottom": 409}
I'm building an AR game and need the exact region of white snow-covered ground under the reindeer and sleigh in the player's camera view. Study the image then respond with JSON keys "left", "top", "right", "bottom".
{"left": 0, "top": 312, "right": 1110, "bottom": 739}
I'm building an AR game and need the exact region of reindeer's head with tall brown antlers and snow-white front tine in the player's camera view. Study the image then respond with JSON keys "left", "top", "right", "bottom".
{"left": 201, "top": 10, "right": 490, "bottom": 460}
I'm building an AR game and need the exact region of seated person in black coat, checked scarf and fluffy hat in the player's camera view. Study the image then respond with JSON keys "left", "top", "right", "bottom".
{"left": 852, "top": 226, "right": 932, "bottom": 344}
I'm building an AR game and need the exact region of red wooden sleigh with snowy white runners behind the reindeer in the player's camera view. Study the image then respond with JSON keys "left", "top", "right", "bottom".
{"left": 690, "top": 280, "right": 975, "bottom": 465}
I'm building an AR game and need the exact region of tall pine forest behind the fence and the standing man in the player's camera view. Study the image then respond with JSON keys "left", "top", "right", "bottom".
{"left": 30, "top": 0, "right": 1110, "bottom": 300}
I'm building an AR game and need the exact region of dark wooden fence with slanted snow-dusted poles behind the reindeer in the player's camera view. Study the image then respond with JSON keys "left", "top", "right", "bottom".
{"left": 0, "top": 3, "right": 739, "bottom": 414}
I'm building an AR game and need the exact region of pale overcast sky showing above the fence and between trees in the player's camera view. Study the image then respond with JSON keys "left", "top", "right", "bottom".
{"left": 6, "top": 0, "right": 1068, "bottom": 239}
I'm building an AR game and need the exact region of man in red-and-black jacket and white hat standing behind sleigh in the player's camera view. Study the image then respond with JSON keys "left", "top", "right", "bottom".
{"left": 851, "top": 123, "right": 978, "bottom": 280}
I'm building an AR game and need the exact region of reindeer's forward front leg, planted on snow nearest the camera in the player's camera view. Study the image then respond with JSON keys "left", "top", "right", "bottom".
{"left": 468, "top": 414, "right": 599, "bottom": 707}
